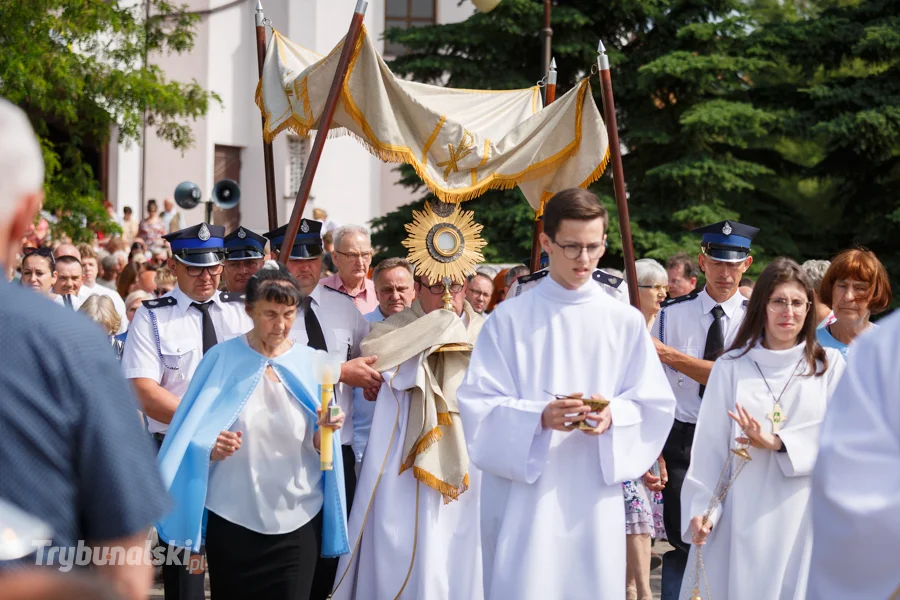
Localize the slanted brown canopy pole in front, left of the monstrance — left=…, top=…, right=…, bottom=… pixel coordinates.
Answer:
left=278, top=0, right=369, bottom=264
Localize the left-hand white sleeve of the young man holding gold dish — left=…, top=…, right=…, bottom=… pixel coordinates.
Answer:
left=456, top=318, right=552, bottom=484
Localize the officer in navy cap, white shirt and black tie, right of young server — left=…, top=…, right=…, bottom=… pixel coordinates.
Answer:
left=652, top=221, right=759, bottom=600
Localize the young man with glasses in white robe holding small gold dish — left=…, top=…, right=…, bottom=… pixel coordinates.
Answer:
left=457, top=189, right=675, bottom=600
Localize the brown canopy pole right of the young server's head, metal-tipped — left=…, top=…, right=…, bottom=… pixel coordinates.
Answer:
left=597, top=41, right=641, bottom=310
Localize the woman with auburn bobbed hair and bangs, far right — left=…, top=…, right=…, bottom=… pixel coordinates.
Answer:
left=816, top=248, right=891, bottom=358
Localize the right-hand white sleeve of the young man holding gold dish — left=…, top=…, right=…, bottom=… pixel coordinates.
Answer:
left=600, top=318, right=675, bottom=485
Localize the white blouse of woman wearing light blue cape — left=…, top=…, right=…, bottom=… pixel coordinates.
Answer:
left=206, top=375, right=323, bottom=534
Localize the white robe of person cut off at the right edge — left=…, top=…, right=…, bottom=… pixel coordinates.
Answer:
left=807, top=316, right=900, bottom=600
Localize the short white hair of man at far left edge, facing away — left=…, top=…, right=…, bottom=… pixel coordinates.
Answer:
left=0, top=98, right=44, bottom=219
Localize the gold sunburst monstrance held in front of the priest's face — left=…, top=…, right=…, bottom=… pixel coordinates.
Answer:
left=403, top=199, right=487, bottom=352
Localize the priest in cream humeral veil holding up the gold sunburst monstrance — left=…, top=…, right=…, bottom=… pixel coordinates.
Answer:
left=333, top=201, right=486, bottom=600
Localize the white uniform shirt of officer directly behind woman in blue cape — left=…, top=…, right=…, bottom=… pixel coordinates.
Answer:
left=291, top=285, right=369, bottom=446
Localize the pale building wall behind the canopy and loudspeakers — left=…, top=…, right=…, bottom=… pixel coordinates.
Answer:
left=109, top=0, right=473, bottom=233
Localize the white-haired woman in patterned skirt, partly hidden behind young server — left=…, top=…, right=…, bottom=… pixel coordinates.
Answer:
left=622, top=258, right=669, bottom=600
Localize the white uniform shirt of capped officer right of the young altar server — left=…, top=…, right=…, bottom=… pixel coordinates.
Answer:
left=652, top=288, right=747, bottom=423
